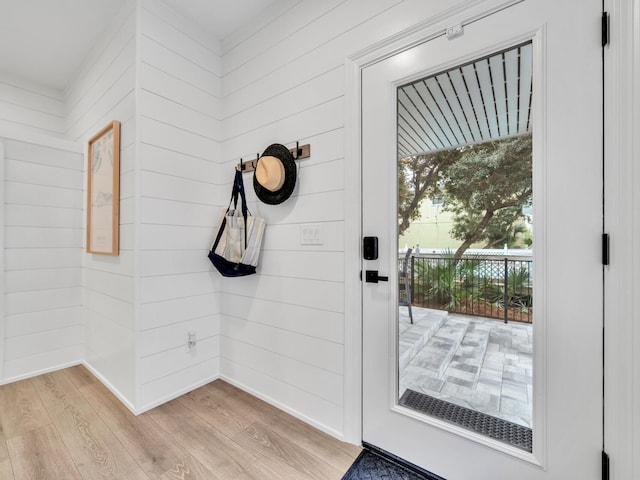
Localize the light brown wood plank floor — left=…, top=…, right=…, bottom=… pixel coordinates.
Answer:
left=0, top=366, right=360, bottom=480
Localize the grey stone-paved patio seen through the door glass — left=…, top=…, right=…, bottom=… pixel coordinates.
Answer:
left=398, top=306, right=533, bottom=428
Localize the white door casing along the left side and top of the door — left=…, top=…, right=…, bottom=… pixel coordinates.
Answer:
left=344, top=0, right=540, bottom=444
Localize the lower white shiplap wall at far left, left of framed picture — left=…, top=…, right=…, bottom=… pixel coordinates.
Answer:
left=1, top=135, right=84, bottom=381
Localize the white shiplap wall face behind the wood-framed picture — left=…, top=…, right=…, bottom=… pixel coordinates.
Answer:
left=65, top=0, right=137, bottom=408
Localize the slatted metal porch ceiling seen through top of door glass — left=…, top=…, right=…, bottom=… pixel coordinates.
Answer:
left=398, top=42, right=532, bottom=158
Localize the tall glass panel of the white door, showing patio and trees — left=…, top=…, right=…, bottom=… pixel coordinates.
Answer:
left=396, top=42, right=533, bottom=452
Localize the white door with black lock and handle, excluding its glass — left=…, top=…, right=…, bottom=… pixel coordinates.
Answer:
left=362, top=0, right=603, bottom=480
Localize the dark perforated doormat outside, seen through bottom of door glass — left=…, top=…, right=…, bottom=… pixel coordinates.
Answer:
left=399, top=389, right=533, bottom=452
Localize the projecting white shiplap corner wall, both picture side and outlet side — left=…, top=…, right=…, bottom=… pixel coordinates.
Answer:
left=58, top=0, right=220, bottom=411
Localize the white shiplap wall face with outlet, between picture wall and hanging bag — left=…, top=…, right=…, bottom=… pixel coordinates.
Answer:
left=136, top=1, right=221, bottom=410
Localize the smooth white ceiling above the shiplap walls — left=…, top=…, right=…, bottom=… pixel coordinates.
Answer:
left=0, top=0, right=276, bottom=90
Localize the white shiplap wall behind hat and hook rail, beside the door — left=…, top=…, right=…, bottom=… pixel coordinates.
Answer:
left=220, top=0, right=468, bottom=438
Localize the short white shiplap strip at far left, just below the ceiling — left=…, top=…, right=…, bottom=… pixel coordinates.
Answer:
left=0, top=73, right=64, bottom=138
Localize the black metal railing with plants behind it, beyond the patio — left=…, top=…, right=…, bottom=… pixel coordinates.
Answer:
left=399, top=253, right=533, bottom=323
